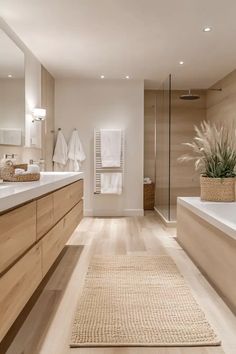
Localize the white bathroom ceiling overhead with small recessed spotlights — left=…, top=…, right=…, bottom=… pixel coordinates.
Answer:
left=0, top=0, right=236, bottom=88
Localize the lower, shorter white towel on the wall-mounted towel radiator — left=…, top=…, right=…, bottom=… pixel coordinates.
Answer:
left=101, top=172, right=122, bottom=194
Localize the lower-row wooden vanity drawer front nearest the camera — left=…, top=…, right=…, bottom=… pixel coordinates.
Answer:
left=0, top=243, right=42, bottom=341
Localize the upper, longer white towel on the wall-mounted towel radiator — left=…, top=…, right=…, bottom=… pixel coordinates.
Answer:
left=100, top=129, right=121, bottom=167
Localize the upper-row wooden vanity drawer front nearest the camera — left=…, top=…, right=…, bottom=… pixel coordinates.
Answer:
left=0, top=202, right=36, bottom=273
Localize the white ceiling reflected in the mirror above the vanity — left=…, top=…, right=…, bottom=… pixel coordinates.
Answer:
left=0, top=29, right=24, bottom=79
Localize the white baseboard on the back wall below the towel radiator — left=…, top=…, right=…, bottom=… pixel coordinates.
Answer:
left=84, top=209, right=144, bottom=217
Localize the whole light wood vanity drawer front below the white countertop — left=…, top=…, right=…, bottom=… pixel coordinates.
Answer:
left=0, top=180, right=83, bottom=341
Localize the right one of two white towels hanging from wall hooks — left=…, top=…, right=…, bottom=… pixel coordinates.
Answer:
left=68, top=129, right=86, bottom=172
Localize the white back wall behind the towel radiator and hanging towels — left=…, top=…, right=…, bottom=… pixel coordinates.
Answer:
left=55, top=79, right=144, bottom=216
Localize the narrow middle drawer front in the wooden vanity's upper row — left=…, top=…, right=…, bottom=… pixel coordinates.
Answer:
left=37, top=193, right=53, bottom=239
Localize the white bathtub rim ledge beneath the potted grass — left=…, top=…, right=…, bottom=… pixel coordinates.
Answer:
left=178, top=197, right=236, bottom=239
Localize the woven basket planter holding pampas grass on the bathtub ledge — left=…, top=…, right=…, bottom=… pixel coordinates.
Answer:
left=200, top=176, right=236, bottom=202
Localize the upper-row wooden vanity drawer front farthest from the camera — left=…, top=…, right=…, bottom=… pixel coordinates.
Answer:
left=53, top=180, right=83, bottom=223
